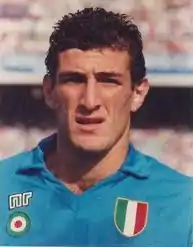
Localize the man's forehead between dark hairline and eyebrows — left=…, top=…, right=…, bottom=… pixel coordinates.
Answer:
left=58, top=49, right=130, bottom=73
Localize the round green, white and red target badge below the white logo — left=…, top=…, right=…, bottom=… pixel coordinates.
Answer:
left=7, top=212, right=31, bottom=237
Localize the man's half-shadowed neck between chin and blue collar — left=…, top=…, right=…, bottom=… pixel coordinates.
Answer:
left=47, top=130, right=129, bottom=193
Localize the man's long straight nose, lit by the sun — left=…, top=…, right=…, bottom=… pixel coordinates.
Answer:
left=81, top=79, right=100, bottom=111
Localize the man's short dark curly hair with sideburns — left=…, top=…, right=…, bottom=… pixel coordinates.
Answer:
left=45, top=8, right=146, bottom=84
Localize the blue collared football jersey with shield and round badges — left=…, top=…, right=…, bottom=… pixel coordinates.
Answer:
left=0, top=136, right=193, bottom=247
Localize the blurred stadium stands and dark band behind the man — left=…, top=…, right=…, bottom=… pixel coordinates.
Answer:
left=0, top=0, right=193, bottom=175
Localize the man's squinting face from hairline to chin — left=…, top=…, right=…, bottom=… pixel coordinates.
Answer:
left=44, top=49, right=149, bottom=152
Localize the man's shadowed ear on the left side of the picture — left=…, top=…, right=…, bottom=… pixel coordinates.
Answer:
left=43, top=75, right=55, bottom=109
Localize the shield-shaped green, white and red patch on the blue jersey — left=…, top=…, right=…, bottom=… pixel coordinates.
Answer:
left=114, top=198, right=148, bottom=237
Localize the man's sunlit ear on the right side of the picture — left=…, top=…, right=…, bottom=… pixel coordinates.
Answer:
left=131, top=78, right=150, bottom=112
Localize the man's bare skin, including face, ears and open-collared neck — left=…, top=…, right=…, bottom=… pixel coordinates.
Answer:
left=43, top=49, right=149, bottom=193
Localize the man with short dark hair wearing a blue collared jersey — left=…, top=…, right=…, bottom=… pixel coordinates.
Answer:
left=0, top=8, right=192, bottom=247
